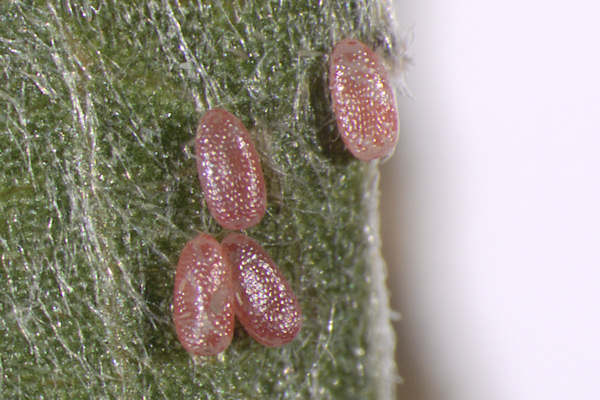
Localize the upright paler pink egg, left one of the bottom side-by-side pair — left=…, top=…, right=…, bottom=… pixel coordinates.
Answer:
left=173, top=233, right=234, bottom=356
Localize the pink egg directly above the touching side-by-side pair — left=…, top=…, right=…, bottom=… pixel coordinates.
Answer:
left=195, top=109, right=267, bottom=230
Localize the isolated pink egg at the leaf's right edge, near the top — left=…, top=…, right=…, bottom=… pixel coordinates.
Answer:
left=329, top=39, right=398, bottom=161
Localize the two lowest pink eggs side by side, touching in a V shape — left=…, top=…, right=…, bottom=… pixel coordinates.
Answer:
left=173, top=232, right=302, bottom=356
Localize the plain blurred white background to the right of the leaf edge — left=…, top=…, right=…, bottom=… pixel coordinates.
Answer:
left=381, top=0, right=600, bottom=400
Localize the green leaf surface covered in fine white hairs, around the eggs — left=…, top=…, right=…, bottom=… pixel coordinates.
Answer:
left=0, top=0, right=394, bottom=399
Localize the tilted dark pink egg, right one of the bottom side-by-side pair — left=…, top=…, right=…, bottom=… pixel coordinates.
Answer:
left=221, top=233, right=302, bottom=347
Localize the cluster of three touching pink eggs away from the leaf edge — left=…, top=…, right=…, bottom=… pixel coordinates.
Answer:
left=173, top=109, right=302, bottom=356
